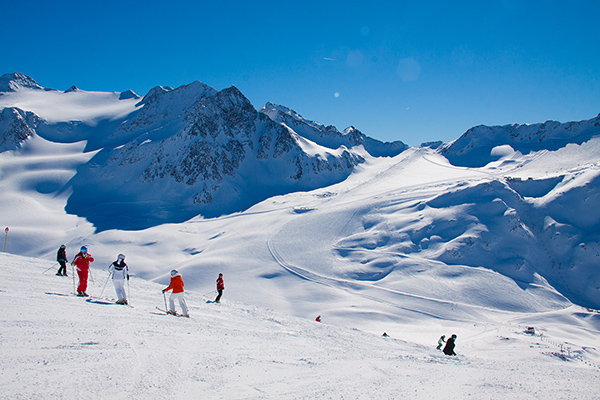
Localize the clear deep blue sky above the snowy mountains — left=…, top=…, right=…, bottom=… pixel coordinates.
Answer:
left=0, top=0, right=600, bottom=145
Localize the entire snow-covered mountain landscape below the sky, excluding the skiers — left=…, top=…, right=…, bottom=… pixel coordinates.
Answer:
left=0, top=74, right=600, bottom=399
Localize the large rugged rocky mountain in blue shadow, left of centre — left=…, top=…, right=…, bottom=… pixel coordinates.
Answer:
left=66, top=82, right=364, bottom=229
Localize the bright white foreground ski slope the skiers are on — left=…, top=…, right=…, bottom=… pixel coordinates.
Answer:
left=0, top=254, right=600, bottom=399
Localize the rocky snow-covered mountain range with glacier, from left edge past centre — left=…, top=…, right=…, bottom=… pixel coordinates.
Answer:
left=0, top=73, right=398, bottom=230
